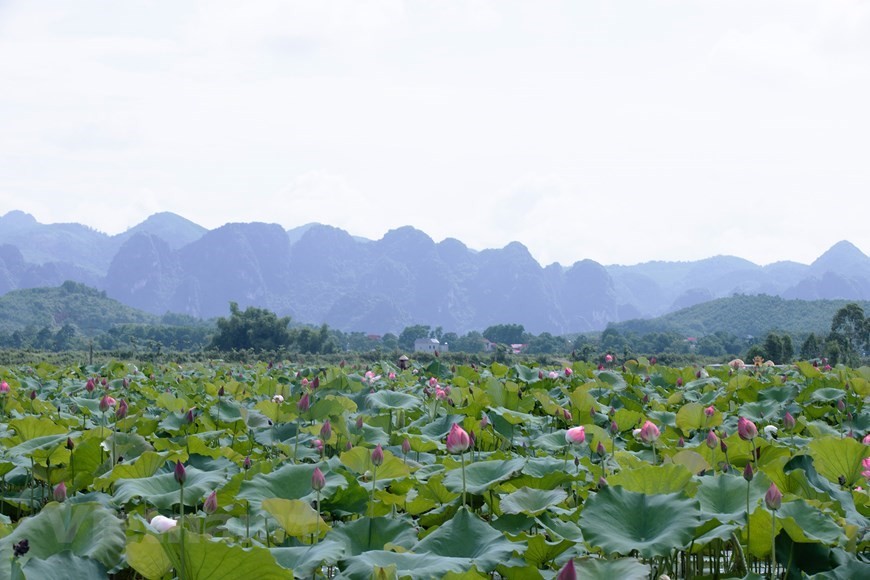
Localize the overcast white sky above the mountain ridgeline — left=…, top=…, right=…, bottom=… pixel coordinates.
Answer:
left=0, top=0, right=870, bottom=265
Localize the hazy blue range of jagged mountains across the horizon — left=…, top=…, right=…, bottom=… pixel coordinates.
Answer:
left=0, top=211, right=870, bottom=334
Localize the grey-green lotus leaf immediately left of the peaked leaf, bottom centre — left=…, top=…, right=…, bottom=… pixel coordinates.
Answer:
left=325, top=517, right=417, bottom=556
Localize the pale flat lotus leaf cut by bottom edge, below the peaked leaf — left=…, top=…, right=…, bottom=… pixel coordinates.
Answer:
left=339, top=550, right=471, bottom=580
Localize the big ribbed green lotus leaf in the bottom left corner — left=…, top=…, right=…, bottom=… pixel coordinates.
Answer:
left=0, top=502, right=125, bottom=569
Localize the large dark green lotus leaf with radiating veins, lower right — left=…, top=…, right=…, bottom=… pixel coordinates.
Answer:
left=579, top=487, right=701, bottom=558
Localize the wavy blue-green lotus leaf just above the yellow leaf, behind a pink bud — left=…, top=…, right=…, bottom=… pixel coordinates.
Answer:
left=240, top=463, right=347, bottom=510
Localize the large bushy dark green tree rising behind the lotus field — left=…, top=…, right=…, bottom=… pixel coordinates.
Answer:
left=211, top=302, right=292, bottom=350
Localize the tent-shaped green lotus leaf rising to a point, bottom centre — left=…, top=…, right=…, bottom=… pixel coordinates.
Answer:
left=413, top=509, right=521, bottom=572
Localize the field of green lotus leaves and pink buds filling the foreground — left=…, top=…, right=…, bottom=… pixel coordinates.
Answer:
left=0, top=358, right=870, bottom=580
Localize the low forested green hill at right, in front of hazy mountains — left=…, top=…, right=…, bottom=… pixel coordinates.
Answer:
left=610, top=295, right=870, bottom=337
